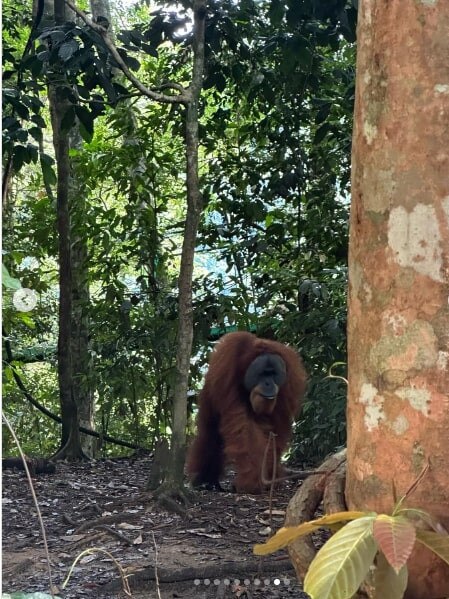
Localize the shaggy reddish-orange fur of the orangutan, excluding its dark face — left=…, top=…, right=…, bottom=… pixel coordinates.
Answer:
left=187, top=332, right=306, bottom=493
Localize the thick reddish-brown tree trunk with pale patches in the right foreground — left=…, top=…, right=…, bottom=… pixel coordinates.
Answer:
left=346, top=0, right=449, bottom=599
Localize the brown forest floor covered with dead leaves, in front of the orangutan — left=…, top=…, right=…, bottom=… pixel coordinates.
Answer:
left=2, top=457, right=307, bottom=599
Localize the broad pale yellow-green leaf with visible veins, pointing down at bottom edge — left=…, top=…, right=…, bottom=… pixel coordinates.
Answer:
left=304, top=516, right=377, bottom=599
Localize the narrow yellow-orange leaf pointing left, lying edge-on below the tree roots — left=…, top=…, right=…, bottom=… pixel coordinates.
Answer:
left=253, top=511, right=366, bottom=555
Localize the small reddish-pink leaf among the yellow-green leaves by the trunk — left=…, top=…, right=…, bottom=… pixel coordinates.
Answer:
left=373, top=514, right=416, bottom=573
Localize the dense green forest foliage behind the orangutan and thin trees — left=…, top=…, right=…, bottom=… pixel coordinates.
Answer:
left=3, top=0, right=356, bottom=461
